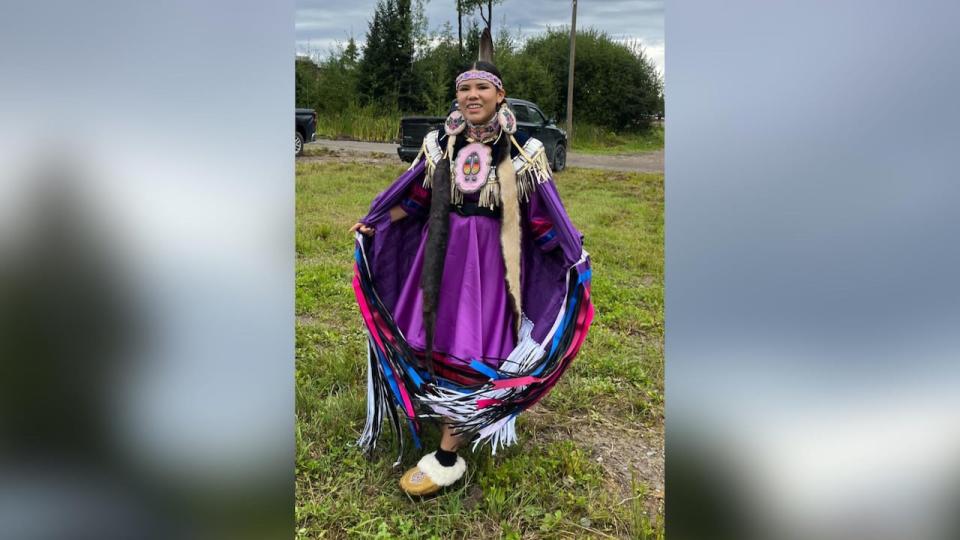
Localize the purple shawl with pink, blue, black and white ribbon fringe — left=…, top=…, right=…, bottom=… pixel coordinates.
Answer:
left=353, top=132, right=593, bottom=463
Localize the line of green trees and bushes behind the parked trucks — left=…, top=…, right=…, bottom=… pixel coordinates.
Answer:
left=304, top=10, right=663, bottom=131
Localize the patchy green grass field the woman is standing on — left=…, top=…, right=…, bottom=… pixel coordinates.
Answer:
left=296, top=158, right=663, bottom=539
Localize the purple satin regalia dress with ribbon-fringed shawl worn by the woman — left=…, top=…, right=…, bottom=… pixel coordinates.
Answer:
left=353, top=127, right=593, bottom=460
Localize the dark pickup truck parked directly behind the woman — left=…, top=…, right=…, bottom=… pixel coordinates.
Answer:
left=397, top=97, right=568, bottom=172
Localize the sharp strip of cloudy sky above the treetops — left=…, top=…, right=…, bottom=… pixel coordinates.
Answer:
left=296, top=0, right=664, bottom=73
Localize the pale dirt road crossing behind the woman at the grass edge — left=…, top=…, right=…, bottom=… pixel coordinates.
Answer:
left=301, top=139, right=663, bottom=173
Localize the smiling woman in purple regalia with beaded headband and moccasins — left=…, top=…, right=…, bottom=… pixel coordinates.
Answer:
left=351, top=61, right=593, bottom=495
